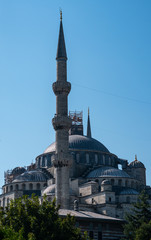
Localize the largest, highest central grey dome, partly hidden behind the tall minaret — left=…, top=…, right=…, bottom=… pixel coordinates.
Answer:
left=44, top=135, right=109, bottom=153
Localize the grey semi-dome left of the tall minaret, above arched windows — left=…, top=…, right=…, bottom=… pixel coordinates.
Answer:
left=13, top=170, right=47, bottom=182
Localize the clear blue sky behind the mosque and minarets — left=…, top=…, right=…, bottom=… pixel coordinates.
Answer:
left=0, top=0, right=151, bottom=186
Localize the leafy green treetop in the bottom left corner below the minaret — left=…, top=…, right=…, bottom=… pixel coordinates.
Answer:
left=0, top=196, right=87, bottom=240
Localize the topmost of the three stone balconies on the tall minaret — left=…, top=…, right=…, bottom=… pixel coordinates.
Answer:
left=52, top=81, right=71, bottom=95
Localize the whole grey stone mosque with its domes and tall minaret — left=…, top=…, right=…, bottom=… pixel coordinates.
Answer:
left=0, top=16, right=151, bottom=239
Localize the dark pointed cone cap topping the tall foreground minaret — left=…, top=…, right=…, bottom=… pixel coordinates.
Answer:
left=56, top=10, right=67, bottom=60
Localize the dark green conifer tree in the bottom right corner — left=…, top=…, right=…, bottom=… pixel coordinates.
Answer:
left=124, top=191, right=151, bottom=240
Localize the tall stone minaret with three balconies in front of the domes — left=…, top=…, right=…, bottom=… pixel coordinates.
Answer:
left=52, top=11, right=72, bottom=209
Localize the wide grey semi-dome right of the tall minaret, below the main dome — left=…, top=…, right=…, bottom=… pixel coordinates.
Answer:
left=86, top=167, right=130, bottom=178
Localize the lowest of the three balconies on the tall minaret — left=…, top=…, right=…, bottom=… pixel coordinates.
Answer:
left=51, top=152, right=73, bottom=167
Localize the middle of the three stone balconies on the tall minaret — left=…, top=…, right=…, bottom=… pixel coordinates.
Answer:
left=52, top=115, right=72, bottom=130
